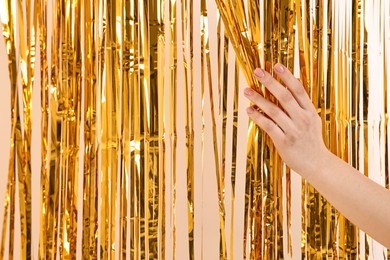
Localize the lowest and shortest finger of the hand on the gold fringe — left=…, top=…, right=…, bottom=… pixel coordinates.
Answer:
left=246, top=107, right=285, bottom=142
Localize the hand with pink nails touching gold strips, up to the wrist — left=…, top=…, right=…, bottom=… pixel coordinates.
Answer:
left=244, top=64, right=330, bottom=177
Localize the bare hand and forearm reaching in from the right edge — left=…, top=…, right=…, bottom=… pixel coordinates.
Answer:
left=244, top=64, right=390, bottom=248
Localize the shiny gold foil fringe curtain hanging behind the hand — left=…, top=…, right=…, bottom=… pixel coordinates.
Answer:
left=0, top=0, right=390, bottom=259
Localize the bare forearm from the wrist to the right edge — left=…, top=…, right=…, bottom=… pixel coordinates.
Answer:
left=301, top=152, right=390, bottom=248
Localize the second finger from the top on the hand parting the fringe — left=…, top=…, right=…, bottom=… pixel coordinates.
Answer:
left=255, top=68, right=302, bottom=117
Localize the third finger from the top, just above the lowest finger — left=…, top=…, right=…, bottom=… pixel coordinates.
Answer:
left=244, top=88, right=294, bottom=132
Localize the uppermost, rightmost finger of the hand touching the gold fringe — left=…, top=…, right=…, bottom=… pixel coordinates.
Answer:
left=274, top=63, right=315, bottom=111
